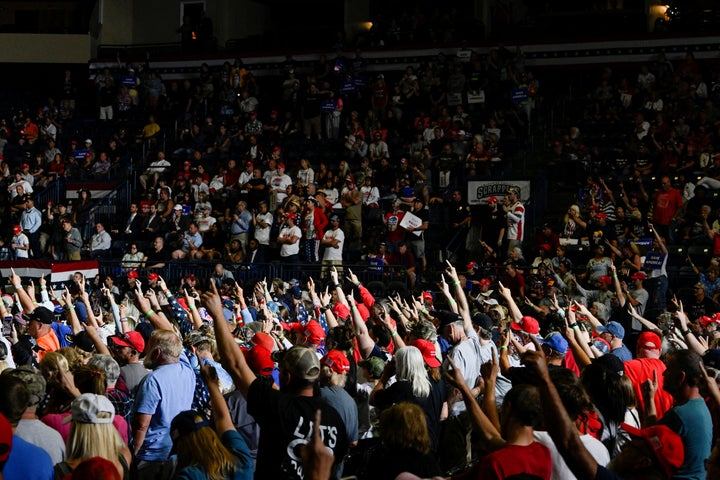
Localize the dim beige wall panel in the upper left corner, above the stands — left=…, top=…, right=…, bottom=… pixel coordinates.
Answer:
left=0, top=33, right=91, bottom=64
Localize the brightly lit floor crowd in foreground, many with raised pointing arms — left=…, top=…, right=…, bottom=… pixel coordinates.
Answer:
left=0, top=249, right=720, bottom=479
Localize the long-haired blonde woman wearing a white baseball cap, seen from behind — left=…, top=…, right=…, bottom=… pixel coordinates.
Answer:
left=55, top=393, right=132, bottom=479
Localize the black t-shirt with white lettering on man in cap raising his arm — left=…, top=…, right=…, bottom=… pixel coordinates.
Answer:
left=247, top=380, right=348, bottom=480
